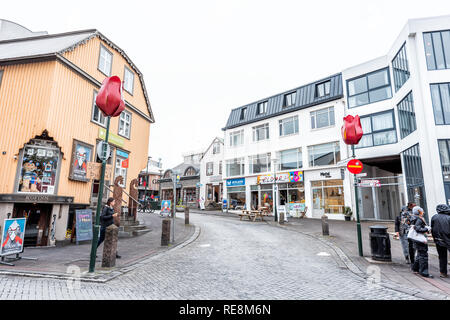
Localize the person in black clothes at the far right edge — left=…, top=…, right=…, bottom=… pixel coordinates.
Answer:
left=431, top=204, right=450, bottom=278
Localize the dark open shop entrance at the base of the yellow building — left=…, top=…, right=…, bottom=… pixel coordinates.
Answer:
left=13, top=203, right=53, bottom=247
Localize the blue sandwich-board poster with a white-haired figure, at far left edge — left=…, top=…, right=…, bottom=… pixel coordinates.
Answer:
left=0, top=218, right=27, bottom=256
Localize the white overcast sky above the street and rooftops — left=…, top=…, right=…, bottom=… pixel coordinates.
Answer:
left=0, top=0, right=450, bottom=168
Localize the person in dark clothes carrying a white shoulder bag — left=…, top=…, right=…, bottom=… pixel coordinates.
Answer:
left=408, top=206, right=433, bottom=278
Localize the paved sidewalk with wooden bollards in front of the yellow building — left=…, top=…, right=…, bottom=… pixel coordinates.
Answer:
left=0, top=211, right=196, bottom=282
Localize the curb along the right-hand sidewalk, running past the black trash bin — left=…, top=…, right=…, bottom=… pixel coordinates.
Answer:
left=266, top=221, right=450, bottom=300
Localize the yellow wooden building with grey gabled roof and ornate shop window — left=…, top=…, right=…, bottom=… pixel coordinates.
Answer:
left=0, top=20, right=154, bottom=246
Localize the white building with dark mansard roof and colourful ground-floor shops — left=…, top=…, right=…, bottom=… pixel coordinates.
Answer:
left=223, top=74, right=351, bottom=219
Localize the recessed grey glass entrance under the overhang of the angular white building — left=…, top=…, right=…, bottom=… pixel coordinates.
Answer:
left=358, top=175, right=406, bottom=220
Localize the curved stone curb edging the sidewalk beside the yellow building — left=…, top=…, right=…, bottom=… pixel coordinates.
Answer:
left=0, top=225, right=201, bottom=283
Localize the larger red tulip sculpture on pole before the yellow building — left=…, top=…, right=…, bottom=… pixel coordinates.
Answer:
left=95, top=76, right=125, bottom=117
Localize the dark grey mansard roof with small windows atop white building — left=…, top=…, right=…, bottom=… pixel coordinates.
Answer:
left=222, top=73, right=344, bottom=131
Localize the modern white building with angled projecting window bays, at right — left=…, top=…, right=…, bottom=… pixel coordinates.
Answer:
left=342, top=16, right=450, bottom=220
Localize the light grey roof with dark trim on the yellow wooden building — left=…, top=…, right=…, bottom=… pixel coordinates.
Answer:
left=0, top=29, right=155, bottom=122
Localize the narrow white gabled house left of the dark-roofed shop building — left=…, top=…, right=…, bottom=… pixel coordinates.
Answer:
left=200, top=137, right=224, bottom=206
